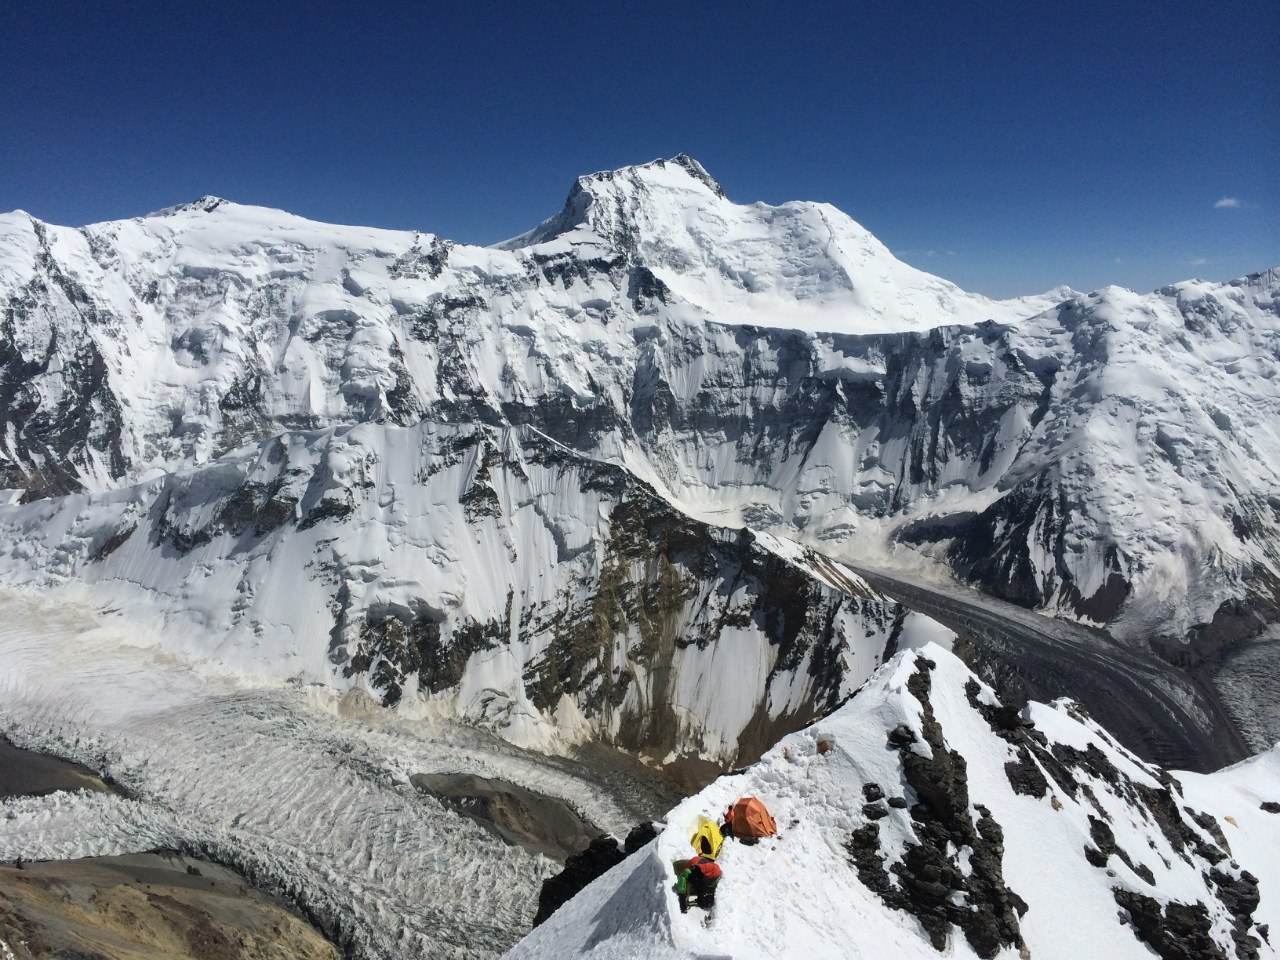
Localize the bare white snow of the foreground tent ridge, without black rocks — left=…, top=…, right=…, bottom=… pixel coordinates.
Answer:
left=507, top=644, right=1280, bottom=960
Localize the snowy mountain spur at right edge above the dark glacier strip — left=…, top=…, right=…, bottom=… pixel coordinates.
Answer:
left=948, top=271, right=1280, bottom=650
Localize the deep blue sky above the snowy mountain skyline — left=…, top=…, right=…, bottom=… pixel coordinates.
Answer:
left=0, top=0, right=1280, bottom=296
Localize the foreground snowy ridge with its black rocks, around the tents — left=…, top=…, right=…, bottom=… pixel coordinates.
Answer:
left=508, top=645, right=1280, bottom=960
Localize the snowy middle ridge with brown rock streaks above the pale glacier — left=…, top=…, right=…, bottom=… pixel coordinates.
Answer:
left=0, top=421, right=916, bottom=776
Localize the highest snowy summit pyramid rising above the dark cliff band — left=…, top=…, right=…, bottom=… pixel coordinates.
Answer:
left=499, top=155, right=1071, bottom=333
